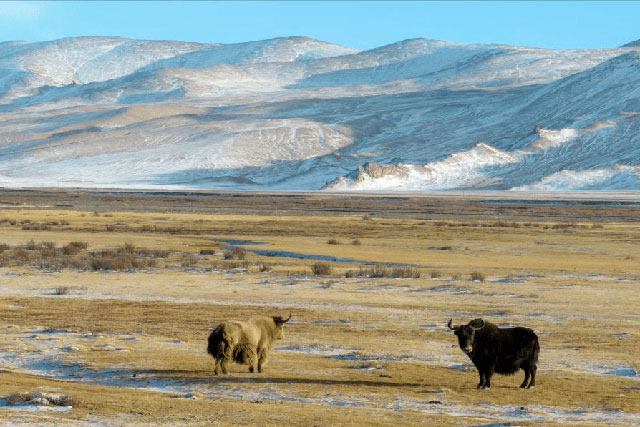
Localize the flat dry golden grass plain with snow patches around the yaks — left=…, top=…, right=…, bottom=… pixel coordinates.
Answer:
left=0, top=191, right=640, bottom=426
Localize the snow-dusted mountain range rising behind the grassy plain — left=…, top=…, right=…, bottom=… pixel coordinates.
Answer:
left=0, top=37, right=640, bottom=191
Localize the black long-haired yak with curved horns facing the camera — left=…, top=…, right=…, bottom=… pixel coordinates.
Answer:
left=447, top=319, right=540, bottom=389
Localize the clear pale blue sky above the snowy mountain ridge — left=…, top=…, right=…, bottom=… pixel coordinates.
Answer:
left=0, top=1, right=640, bottom=49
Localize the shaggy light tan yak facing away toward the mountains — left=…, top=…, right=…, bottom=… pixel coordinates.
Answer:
left=207, top=314, right=291, bottom=375
